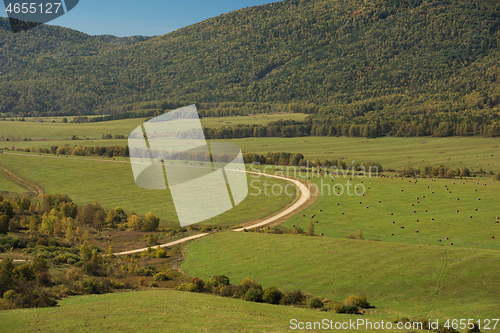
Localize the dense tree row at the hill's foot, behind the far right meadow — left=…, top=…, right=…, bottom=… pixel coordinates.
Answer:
left=203, top=113, right=500, bottom=139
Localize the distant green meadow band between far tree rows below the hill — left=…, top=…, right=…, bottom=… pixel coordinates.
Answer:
left=0, top=113, right=500, bottom=172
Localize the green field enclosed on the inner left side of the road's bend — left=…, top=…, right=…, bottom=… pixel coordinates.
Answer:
left=0, top=154, right=294, bottom=226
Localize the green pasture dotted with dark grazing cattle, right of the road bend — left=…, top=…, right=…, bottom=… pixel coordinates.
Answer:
left=276, top=172, right=500, bottom=250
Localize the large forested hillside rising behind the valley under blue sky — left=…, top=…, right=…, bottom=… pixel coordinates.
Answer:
left=0, top=0, right=500, bottom=135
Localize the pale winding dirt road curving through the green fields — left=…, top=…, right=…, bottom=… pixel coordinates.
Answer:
left=114, top=171, right=311, bottom=255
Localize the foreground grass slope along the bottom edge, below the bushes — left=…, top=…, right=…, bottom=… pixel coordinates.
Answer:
left=0, top=290, right=402, bottom=333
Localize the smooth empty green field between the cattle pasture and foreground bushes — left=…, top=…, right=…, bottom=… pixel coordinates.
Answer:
left=182, top=232, right=500, bottom=322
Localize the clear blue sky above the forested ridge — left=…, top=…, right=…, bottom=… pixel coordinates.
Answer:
left=0, top=0, right=277, bottom=37
